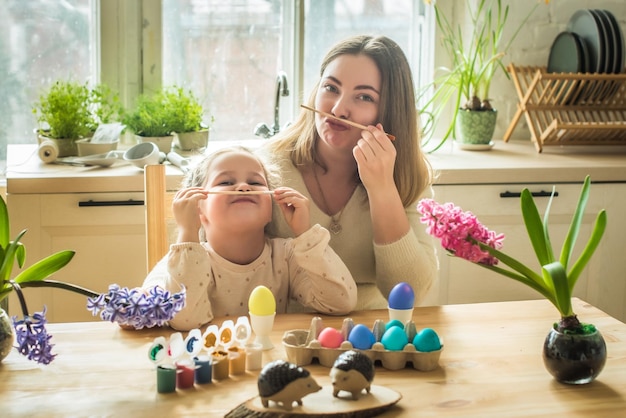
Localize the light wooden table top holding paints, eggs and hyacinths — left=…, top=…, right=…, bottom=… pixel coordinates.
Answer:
left=0, top=300, right=626, bottom=418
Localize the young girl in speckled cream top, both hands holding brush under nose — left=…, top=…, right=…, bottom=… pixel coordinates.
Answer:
left=144, top=147, right=357, bottom=330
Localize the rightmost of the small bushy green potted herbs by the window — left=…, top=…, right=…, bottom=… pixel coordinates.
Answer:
left=165, top=86, right=209, bottom=150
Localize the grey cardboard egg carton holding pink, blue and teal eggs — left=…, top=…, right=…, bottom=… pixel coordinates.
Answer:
left=282, top=319, right=443, bottom=372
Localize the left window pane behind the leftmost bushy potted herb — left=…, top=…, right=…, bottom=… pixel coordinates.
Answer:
left=0, top=0, right=98, bottom=172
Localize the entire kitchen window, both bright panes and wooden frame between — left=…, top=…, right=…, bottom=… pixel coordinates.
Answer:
left=0, top=0, right=432, bottom=172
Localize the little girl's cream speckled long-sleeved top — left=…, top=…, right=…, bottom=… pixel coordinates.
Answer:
left=143, top=225, right=357, bottom=330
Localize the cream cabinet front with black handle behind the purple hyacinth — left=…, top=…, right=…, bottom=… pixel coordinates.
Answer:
left=7, top=192, right=146, bottom=322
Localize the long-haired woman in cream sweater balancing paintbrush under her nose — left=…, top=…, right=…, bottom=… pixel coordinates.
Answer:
left=260, top=36, right=438, bottom=309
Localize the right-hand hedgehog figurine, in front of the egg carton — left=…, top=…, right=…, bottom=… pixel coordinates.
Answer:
left=330, top=350, right=376, bottom=400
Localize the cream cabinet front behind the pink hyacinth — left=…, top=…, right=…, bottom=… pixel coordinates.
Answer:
left=428, top=183, right=626, bottom=320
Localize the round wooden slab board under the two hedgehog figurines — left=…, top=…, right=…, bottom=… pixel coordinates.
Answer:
left=225, top=383, right=402, bottom=418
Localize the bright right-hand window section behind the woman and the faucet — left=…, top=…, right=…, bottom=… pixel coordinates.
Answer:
left=161, top=0, right=432, bottom=140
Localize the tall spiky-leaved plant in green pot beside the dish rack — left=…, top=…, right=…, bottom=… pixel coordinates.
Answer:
left=418, top=0, right=537, bottom=152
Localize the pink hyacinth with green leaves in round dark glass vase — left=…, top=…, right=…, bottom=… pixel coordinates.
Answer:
left=418, top=176, right=607, bottom=384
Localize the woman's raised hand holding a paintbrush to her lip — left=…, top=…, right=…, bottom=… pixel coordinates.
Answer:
left=352, top=123, right=396, bottom=194
